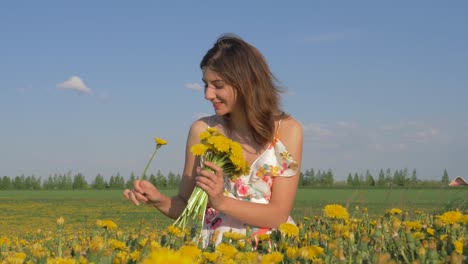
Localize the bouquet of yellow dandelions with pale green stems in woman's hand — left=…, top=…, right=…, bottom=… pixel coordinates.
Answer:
left=174, top=127, right=250, bottom=233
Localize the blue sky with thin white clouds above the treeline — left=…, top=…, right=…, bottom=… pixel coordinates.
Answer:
left=0, top=1, right=468, bottom=182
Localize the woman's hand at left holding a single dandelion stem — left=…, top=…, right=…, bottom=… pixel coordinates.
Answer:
left=123, top=180, right=163, bottom=205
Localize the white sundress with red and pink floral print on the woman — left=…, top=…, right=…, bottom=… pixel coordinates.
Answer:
left=201, top=120, right=298, bottom=246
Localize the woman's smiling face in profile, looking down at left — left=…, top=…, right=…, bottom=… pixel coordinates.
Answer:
left=203, top=68, right=236, bottom=116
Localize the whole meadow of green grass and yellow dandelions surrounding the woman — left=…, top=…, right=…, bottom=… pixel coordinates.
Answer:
left=0, top=188, right=468, bottom=264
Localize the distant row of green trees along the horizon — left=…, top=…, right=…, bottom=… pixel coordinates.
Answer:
left=0, top=169, right=449, bottom=190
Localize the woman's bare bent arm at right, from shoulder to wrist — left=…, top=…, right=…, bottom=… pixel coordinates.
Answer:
left=200, top=117, right=303, bottom=228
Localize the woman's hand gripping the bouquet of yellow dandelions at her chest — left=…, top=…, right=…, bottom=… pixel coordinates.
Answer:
left=195, top=161, right=226, bottom=210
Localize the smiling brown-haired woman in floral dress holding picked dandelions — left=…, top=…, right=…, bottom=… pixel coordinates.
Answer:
left=124, top=35, right=302, bottom=244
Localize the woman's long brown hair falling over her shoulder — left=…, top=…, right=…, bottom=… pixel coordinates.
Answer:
left=200, top=34, right=287, bottom=146
